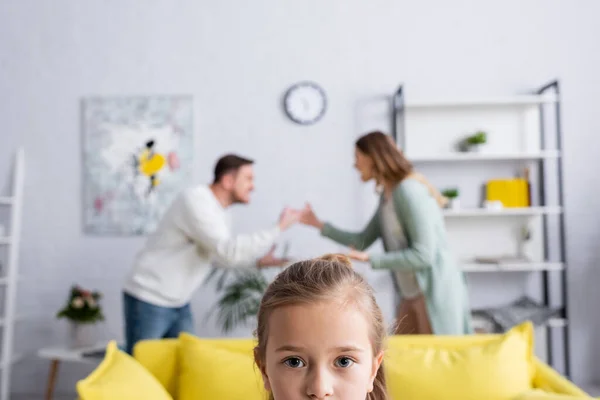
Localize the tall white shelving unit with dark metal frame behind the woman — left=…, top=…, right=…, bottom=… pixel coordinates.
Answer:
left=392, top=81, right=570, bottom=377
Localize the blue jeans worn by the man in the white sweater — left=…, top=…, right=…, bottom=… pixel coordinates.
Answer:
left=123, top=293, right=194, bottom=354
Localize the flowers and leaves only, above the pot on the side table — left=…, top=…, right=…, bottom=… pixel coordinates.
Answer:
left=56, top=286, right=104, bottom=324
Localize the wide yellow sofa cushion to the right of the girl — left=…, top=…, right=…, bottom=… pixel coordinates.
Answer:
left=384, top=323, right=534, bottom=400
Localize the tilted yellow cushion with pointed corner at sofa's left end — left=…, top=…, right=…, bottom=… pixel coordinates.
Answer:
left=77, top=341, right=173, bottom=400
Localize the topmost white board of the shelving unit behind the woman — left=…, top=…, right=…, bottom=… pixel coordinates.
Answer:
left=404, top=95, right=558, bottom=109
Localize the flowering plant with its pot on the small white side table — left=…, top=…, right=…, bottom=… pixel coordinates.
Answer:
left=56, top=285, right=104, bottom=348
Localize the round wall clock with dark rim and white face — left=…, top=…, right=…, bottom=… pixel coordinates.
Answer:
left=284, top=82, right=327, bottom=125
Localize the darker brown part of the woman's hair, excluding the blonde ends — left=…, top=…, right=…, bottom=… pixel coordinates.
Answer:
left=356, top=131, right=413, bottom=184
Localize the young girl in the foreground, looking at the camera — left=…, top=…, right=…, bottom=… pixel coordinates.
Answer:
left=254, top=255, right=388, bottom=400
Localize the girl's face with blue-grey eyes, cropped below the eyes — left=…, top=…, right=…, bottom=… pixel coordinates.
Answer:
left=261, top=302, right=383, bottom=400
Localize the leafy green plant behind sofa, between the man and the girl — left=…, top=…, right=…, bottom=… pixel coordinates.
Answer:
left=205, top=268, right=269, bottom=333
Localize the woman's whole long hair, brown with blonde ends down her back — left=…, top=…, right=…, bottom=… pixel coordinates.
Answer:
left=355, top=131, right=448, bottom=208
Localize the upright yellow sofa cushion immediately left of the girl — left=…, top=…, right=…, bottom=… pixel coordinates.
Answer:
left=178, top=333, right=267, bottom=400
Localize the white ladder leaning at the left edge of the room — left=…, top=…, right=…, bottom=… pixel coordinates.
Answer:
left=0, top=148, right=25, bottom=400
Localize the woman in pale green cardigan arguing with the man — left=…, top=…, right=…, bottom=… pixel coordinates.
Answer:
left=301, top=132, right=473, bottom=335
